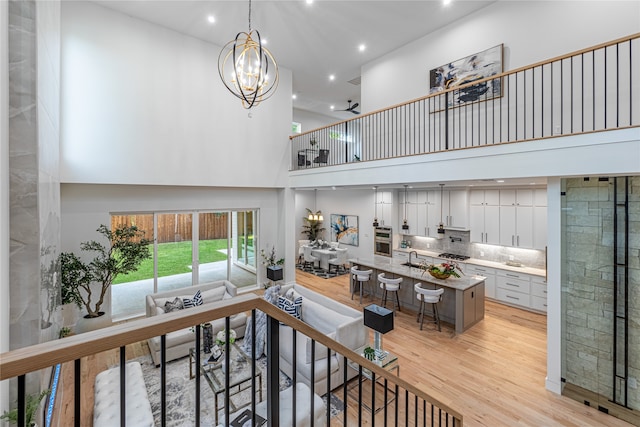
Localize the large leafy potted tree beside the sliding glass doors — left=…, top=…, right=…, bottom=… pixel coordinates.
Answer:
left=60, top=225, right=151, bottom=332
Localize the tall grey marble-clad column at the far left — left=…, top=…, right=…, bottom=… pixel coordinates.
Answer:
left=8, top=0, right=60, bottom=349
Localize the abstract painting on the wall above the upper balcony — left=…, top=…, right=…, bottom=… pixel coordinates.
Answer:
left=429, top=44, right=503, bottom=108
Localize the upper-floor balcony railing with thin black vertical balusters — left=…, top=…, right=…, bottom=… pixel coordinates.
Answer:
left=289, top=33, right=640, bottom=171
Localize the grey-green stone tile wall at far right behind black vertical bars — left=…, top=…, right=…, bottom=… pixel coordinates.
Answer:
left=562, top=176, right=640, bottom=409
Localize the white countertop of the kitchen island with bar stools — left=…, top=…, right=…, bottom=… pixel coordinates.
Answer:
left=349, top=255, right=485, bottom=291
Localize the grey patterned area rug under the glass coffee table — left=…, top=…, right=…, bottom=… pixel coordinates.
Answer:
left=136, top=350, right=344, bottom=427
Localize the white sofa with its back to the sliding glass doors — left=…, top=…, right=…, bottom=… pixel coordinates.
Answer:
left=146, top=280, right=247, bottom=366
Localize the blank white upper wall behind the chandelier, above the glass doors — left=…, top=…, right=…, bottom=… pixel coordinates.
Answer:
left=61, top=2, right=292, bottom=187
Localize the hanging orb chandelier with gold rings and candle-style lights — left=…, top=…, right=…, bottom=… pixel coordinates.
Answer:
left=218, top=0, right=278, bottom=109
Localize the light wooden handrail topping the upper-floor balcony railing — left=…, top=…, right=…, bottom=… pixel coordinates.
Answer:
left=289, top=33, right=640, bottom=141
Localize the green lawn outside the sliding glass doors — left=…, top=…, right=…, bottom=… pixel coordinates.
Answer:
left=113, top=239, right=227, bottom=284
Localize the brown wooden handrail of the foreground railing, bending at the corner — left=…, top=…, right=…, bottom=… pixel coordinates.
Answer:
left=0, top=293, right=463, bottom=426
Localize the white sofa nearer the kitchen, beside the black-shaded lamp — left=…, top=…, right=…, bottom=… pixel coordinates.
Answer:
left=280, top=284, right=367, bottom=396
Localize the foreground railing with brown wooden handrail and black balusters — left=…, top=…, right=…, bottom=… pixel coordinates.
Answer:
left=0, top=294, right=463, bottom=426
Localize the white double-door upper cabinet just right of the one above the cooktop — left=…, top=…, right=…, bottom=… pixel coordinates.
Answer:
left=469, top=190, right=500, bottom=245
